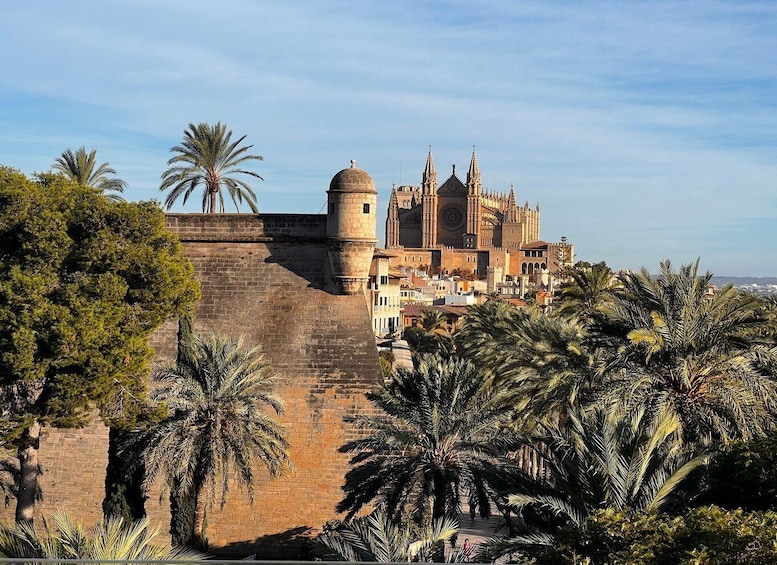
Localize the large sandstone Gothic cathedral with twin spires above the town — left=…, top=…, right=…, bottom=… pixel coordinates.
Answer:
left=386, top=150, right=572, bottom=278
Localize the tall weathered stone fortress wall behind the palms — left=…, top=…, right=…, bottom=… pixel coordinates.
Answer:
left=0, top=214, right=381, bottom=557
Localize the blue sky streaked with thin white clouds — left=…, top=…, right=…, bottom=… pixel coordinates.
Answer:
left=0, top=0, right=777, bottom=276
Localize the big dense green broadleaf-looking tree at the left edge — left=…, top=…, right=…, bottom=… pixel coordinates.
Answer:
left=0, top=168, right=199, bottom=520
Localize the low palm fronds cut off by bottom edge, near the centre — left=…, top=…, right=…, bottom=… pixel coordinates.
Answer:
left=313, top=510, right=463, bottom=563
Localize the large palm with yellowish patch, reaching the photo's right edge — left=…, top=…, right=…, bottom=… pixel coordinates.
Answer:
left=606, top=261, right=777, bottom=443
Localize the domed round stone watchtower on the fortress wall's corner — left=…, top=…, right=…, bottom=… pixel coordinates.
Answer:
left=326, top=161, right=378, bottom=294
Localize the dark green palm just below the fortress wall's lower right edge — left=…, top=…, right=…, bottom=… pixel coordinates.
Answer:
left=337, top=355, right=513, bottom=526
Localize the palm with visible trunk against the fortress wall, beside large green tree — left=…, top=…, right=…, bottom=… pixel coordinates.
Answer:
left=144, top=334, right=290, bottom=540
